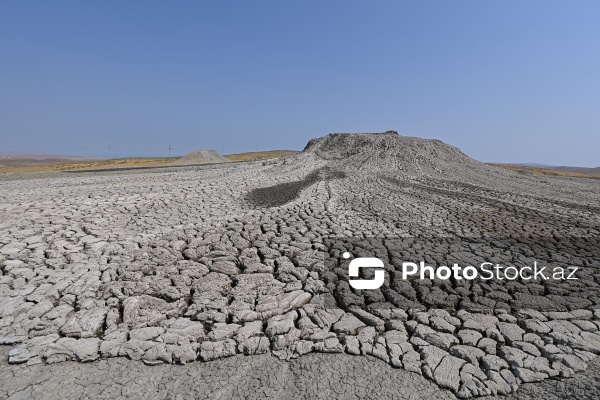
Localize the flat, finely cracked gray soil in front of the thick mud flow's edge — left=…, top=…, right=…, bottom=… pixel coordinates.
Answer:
left=0, top=346, right=454, bottom=400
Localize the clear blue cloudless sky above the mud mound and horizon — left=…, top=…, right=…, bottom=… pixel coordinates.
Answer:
left=0, top=0, right=600, bottom=166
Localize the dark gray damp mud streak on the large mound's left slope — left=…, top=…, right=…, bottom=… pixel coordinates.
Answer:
left=248, top=168, right=346, bottom=207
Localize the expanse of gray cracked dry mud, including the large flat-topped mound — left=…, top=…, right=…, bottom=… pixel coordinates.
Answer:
left=0, top=132, right=600, bottom=399
